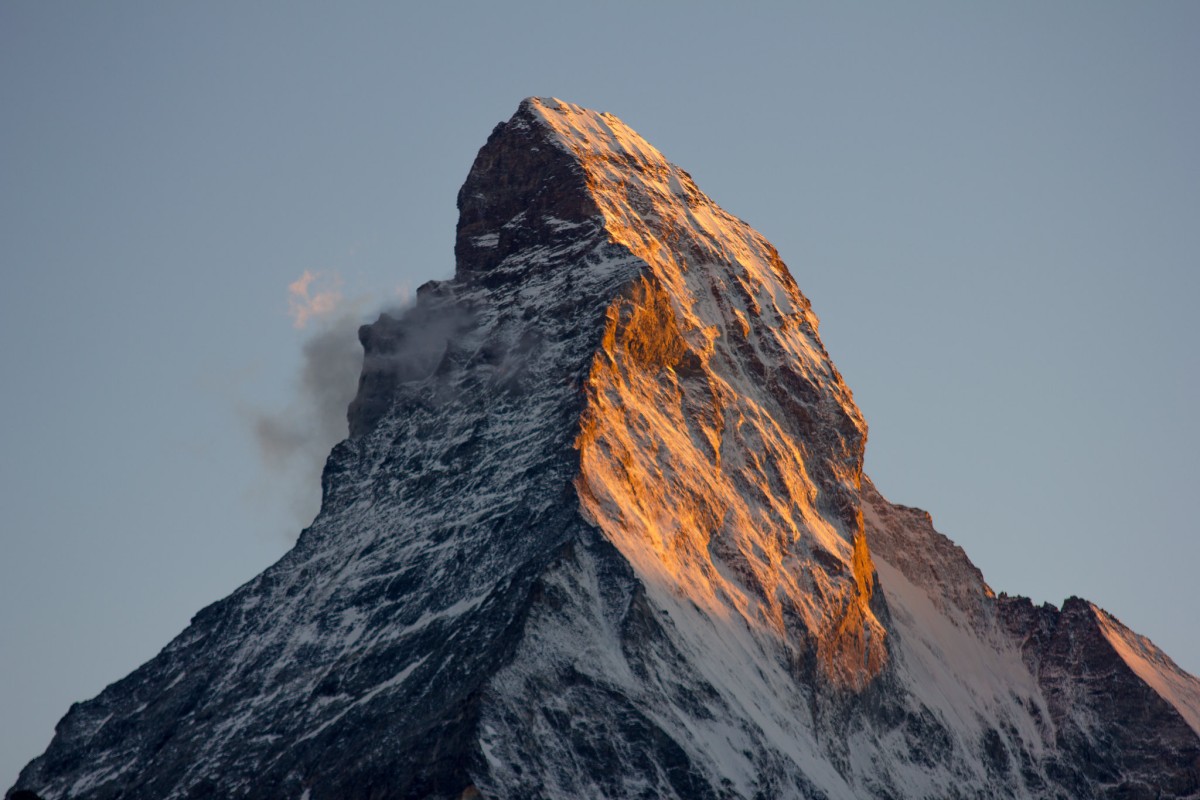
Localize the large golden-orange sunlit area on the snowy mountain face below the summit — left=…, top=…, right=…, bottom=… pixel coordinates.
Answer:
left=534, top=101, right=887, bottom=690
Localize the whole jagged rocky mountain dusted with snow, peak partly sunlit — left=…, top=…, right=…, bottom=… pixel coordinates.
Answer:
left=7, top=98, right=1200, bottom=800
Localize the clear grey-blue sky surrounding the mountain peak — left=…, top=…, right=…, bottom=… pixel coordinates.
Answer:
left=0, top=0, right=1200, bottom=788
